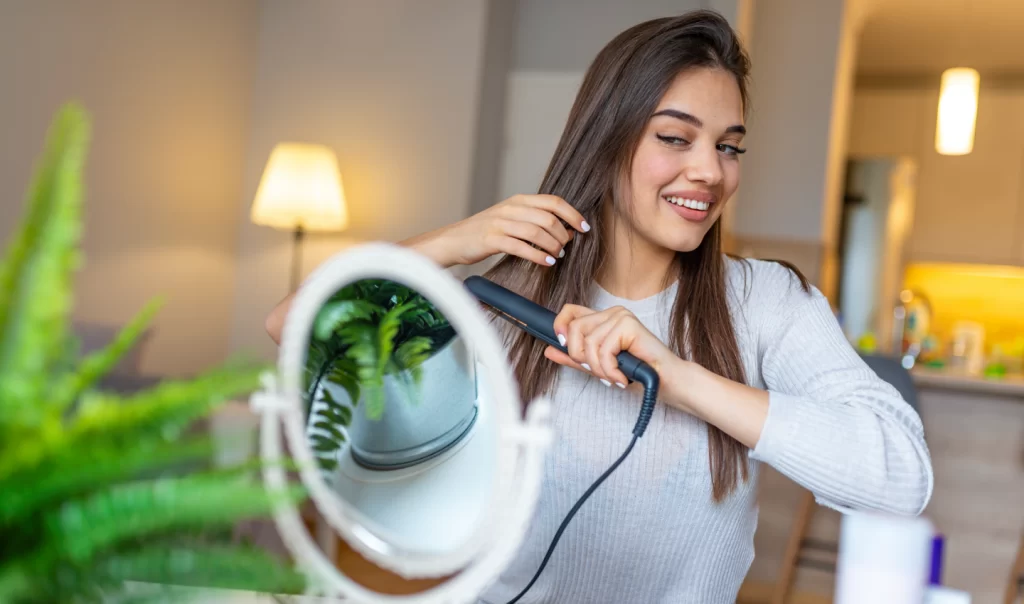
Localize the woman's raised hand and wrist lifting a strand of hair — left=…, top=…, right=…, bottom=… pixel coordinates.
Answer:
left=404, top=195, right=590, bottom=267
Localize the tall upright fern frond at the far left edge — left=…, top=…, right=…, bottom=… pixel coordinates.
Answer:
left=0, top=104, right=89, bottom=434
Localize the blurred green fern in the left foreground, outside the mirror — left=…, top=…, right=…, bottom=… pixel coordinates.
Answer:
left=0, top=104, right=305, bottom=604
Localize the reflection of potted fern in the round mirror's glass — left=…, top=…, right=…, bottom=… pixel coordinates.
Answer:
left=304, top=278, right=497, bottom=581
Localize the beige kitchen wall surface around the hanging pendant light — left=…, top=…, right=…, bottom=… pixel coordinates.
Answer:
left=850, top=83, right=1024, bottom=266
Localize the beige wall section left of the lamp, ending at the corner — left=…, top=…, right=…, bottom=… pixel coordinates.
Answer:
left=0, top=0, right=257, bottom=375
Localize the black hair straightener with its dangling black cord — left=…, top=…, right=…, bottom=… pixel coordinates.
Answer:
left=463, top=276, right=658, bottom=604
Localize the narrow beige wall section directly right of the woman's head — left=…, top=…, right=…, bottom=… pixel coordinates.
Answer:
left=731, top=0, right=865, bottom=293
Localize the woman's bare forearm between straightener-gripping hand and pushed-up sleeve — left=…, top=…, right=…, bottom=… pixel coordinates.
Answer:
left=660, top=357, right=768, bottom=448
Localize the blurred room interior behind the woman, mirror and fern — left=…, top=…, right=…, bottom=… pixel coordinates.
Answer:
left=0, top=0, right=1024, bottom=604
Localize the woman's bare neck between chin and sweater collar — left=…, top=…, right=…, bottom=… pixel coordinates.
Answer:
left=597, top=212, right=676, bottom=300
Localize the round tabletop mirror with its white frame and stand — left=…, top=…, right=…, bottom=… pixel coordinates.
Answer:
left=254, top=244, right=550, bottom=602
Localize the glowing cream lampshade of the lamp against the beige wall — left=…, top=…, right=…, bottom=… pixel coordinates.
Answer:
left=250, top=142, right=348, bottom=230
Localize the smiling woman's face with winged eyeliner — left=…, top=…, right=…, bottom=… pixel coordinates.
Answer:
left=627, top=69, right=745, bottom=252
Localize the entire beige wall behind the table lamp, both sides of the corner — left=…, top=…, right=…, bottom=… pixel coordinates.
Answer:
left=0, top=0, right=493, bottom=375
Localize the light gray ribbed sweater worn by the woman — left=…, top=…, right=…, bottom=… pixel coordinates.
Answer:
left=480, top=260, right=932, bottom=604
